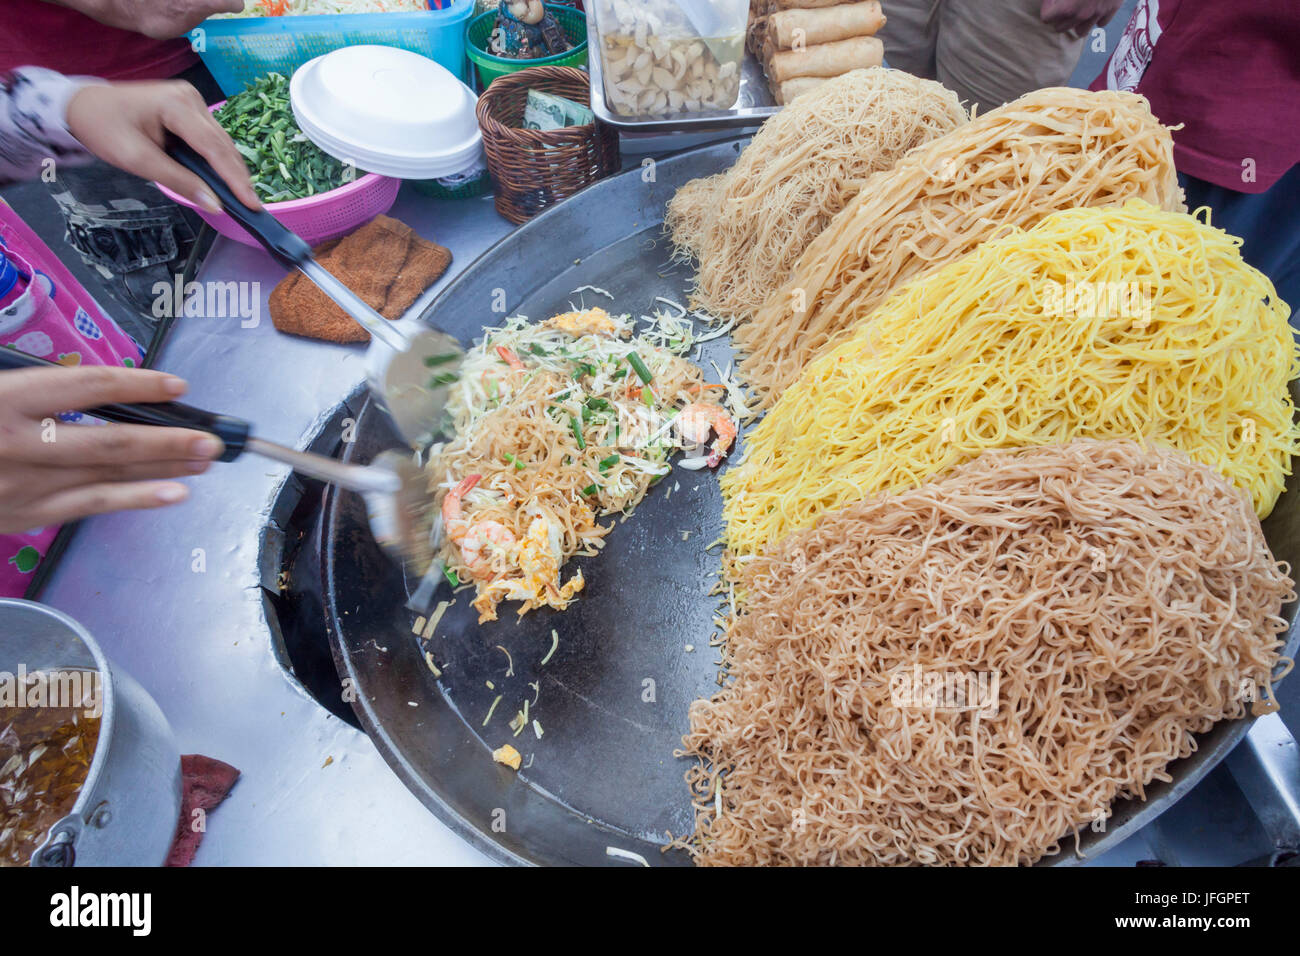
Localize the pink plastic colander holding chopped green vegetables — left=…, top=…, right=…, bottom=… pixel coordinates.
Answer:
left=159, top=100, right=402, bottom=248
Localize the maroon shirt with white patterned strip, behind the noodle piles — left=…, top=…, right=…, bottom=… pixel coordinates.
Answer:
left=1092, top=0, right=1300, bottom=193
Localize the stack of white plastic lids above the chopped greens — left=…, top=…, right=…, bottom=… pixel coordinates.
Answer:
left=289, top=46, right=482, bottom=179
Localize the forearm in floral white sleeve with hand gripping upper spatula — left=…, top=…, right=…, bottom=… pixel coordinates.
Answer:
left=0, top=66, right=261, bottom=212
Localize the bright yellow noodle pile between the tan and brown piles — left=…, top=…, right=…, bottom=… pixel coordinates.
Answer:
left=722, top=200, right=1300, bottom=554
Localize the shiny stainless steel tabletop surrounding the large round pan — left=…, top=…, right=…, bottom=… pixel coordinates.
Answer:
left=35, top=179, right=1284, bottom=866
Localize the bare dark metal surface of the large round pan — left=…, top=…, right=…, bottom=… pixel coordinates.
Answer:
left=326, top=217, right=729, bottom=862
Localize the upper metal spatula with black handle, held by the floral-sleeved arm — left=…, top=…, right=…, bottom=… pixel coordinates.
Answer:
left=166, top=137, right=464, bottom=447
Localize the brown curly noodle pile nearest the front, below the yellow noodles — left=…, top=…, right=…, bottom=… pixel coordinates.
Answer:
left=685, top=441, right=1294, bottom=865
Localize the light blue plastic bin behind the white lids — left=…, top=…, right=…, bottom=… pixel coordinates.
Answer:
left=190, top=0, right=475, bottom=96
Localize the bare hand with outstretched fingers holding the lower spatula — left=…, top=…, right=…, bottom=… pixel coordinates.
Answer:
left=0, top=365, right=222, bottom=535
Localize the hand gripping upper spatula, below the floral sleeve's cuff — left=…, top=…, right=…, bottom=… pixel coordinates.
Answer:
left=68, top=79, right=261, bottom=212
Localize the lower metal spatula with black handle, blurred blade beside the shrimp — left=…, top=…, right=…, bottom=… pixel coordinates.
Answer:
left=0, top=349, right=442, bottom=580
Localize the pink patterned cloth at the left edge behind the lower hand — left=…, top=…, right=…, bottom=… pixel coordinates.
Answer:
left=0, top=202, right=143, bottom=597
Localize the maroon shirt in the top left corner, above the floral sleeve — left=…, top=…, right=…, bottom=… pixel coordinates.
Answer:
left=0, top=0, right=198, bottom=79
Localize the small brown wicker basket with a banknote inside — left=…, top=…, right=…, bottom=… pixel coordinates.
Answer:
left=478, top=66, right=619, bottom=224
